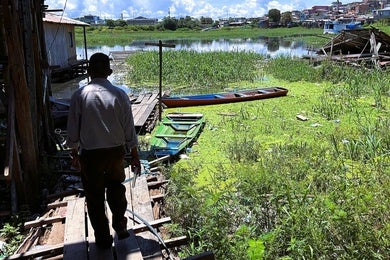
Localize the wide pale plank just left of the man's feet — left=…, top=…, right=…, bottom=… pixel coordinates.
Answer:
left=64, top=198, right=88, bottom=260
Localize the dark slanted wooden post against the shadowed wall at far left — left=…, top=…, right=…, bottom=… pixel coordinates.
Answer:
left=1, top=0, right=40, bottom=210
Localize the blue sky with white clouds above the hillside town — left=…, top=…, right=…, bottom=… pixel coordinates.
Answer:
left=45, top=0, right=356, bottom=20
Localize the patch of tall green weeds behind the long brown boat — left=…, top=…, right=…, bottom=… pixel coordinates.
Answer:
left=127, top=50, right=263, bottom=94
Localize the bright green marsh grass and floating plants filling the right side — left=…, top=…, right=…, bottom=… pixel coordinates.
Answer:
left=133, top=53, right=390, bottom=259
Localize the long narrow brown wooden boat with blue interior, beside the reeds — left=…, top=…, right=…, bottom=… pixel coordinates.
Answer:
left=161, top=87, right=288, bottom=108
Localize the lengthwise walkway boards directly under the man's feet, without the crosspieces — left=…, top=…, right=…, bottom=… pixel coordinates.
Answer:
left=63, top=168, right=164, bottom=260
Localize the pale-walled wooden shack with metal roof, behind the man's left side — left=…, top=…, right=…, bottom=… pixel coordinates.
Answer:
left=43, top=13, right=89, bottom=81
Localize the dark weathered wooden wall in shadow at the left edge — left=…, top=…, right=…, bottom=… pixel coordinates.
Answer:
left=0, top=0, right=53, bottom=211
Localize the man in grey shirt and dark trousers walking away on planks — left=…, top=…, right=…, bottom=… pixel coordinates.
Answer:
left=67, top=53, right=140, bottom=248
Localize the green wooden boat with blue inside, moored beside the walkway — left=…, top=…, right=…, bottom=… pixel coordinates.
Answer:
left=150, top=113, right=205, bottom=157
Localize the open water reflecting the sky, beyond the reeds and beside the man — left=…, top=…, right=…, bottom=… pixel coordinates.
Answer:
left=52, top=37, right=314, bottom=98
